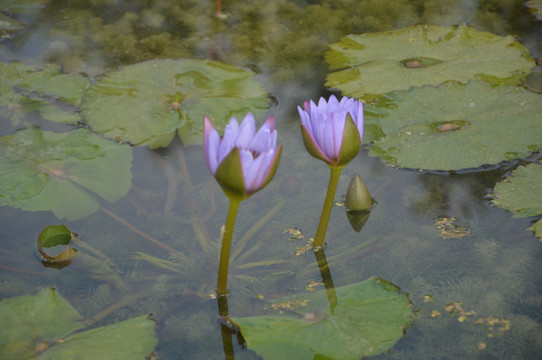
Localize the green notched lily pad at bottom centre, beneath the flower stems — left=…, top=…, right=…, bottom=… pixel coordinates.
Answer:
left=235, top=278, right=413, bottom=360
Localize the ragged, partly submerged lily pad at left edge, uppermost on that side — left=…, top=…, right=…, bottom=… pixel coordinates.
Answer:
left=0, top=63, right=89, bottom=126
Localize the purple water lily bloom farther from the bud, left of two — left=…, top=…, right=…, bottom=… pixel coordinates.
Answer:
left=203, top=113, right=282, bottom=200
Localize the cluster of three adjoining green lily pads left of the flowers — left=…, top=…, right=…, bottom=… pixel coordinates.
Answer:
left=0, top=59, right=269, bottom=220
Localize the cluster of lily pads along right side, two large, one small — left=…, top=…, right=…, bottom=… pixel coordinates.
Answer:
left=326, top=23, right=542, bottom=237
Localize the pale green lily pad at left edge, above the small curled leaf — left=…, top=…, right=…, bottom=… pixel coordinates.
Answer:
left=0, top=128, right=132, bottom=220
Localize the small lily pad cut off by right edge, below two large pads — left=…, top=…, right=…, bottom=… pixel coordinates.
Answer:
left=493, top=164, right=542, bottom=239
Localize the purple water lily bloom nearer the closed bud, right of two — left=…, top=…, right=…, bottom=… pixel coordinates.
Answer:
left=297, top=95, right=363, bottom=167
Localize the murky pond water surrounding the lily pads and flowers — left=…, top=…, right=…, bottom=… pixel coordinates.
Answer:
left=0, top=0, right=542, bottom=359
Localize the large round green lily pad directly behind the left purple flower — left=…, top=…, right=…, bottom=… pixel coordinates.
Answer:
left=81, top=59, right=269, bottom=148
